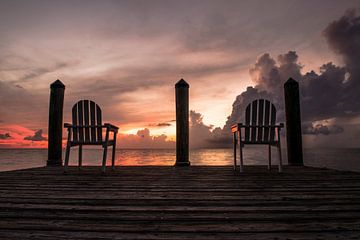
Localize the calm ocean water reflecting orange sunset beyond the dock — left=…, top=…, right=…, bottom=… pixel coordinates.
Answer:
left=0, top=146, right=360, bottom=171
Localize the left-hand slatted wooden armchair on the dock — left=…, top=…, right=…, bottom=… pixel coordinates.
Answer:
left=64, top=100, right=119, bottom=173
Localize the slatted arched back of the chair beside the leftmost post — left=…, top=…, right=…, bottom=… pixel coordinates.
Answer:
left=72, top=100, right=102, bottom=143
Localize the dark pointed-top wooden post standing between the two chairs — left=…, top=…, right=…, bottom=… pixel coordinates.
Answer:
left=175, top=79, right=190, bottom=166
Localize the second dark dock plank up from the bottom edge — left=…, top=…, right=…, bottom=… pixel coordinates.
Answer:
left=0, top=218, right=360, bottom=233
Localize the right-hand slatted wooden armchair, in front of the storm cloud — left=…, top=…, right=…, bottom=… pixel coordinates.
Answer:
left=231, top=99, right=284, bottom=172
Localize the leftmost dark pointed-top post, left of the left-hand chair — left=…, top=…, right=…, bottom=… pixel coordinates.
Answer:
left=47, top=80, right=65, bottom=166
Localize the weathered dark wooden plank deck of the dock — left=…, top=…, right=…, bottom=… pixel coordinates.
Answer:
left=0, top=166, right=360, bottom=239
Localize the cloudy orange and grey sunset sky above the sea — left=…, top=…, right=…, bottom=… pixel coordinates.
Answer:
left=0, top=0, right=360, bottom=148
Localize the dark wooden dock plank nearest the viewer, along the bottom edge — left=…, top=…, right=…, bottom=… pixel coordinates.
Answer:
left=0, top=230, right=360, bottom=240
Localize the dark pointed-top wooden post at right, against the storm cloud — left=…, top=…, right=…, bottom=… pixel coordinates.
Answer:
left=284, top=78, right=304, bottom=166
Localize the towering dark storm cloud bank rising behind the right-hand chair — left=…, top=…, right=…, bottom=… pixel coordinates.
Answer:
left=197, top=10, right=360, bottom=144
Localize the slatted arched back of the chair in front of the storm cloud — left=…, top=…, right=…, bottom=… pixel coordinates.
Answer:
left=244, top=99, right=276, bottom=142
